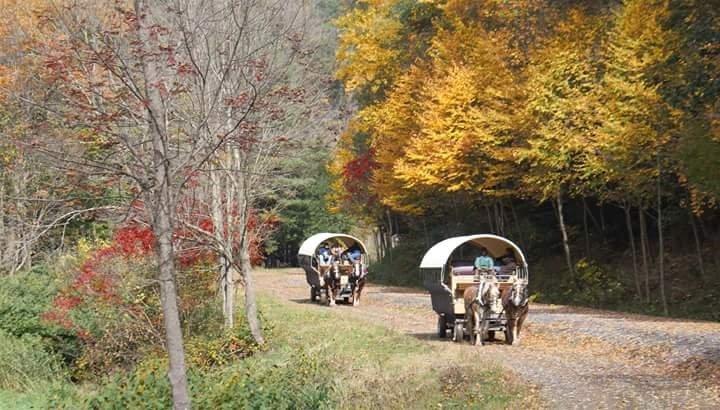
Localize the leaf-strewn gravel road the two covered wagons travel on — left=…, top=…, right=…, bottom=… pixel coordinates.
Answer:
left=256, top=269, right=720, bottom=409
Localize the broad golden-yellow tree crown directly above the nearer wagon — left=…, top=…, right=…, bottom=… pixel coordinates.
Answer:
left=394, top=21, right=516, bottom=199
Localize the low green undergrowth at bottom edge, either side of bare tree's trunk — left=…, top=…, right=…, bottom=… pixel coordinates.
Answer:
left=86, top=351, right=333, bottom=409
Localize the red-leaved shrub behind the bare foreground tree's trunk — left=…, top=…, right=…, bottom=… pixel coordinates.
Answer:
left=44, top=232, right=217, bottom=379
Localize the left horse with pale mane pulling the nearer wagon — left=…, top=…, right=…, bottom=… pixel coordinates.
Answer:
left=463, top=276, right=502, bottom=345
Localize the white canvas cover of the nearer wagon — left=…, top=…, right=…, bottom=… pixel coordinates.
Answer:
left=420, top=234, right=527, bottom=269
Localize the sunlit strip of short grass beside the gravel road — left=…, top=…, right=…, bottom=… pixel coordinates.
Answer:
left=250, top=298, right=525, bottom=409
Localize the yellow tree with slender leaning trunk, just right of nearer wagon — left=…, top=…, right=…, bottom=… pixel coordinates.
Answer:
left=518, top=10, right=600, bottom=279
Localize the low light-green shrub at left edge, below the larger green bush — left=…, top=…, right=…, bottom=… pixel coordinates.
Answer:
left=0, top=330, right=67, bottom=391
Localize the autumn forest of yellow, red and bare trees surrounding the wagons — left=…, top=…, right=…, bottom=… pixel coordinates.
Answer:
left=0, top=0, right=720, bottom=408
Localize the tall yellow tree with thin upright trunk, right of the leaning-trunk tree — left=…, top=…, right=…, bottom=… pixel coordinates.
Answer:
left=598, top=0, right=678, bottom=314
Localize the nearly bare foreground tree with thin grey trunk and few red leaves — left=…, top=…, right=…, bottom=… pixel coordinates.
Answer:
left=31, top=0, right=312, bottom=408
